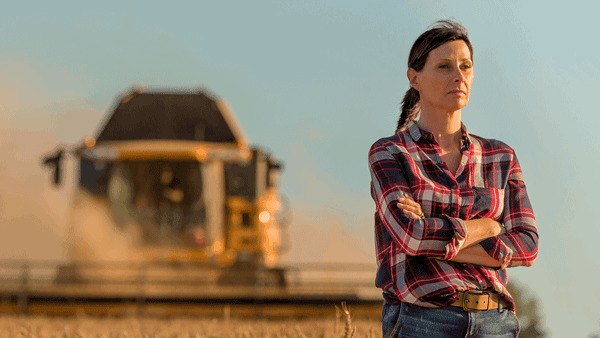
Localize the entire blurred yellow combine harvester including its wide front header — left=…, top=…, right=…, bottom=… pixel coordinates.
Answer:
left=0, top=89, right=381, bottom=317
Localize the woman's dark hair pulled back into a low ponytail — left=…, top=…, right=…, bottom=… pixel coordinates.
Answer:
left=396, top=20, right=473, bottom=132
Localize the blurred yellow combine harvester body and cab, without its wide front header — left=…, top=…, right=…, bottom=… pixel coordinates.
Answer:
left=44, top=89, right=289, bottom=287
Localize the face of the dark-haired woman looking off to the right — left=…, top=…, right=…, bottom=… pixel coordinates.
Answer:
left=407, top=40, right=473, bottom=112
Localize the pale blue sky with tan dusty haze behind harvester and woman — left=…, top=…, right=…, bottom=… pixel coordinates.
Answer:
left=0, top=0, right=600, bottom=337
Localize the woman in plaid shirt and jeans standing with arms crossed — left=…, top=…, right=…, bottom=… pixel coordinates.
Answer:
left=369, top=21, right=538, bottom=337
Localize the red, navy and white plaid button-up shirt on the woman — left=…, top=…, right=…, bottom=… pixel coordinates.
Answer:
left=369, top=122, right=538, bottom=309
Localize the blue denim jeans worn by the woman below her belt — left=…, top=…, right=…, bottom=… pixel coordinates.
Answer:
left=381, top=297, right=519, bottom=338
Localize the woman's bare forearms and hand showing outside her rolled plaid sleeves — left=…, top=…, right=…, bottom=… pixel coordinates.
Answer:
left=397, top=194, right=505, bottom=268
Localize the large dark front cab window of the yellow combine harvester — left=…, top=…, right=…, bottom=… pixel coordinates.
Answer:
left=102, top=161, right=206, bottom=246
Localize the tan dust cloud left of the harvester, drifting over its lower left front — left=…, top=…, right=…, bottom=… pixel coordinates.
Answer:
left=0, top=96, right=141, bottom=261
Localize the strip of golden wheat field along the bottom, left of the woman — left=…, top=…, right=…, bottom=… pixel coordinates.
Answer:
left=0, top=307, right=381, bottom=338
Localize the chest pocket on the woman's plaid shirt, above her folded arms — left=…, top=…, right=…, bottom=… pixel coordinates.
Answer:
left=468, top=187, right=504, bottom=222
